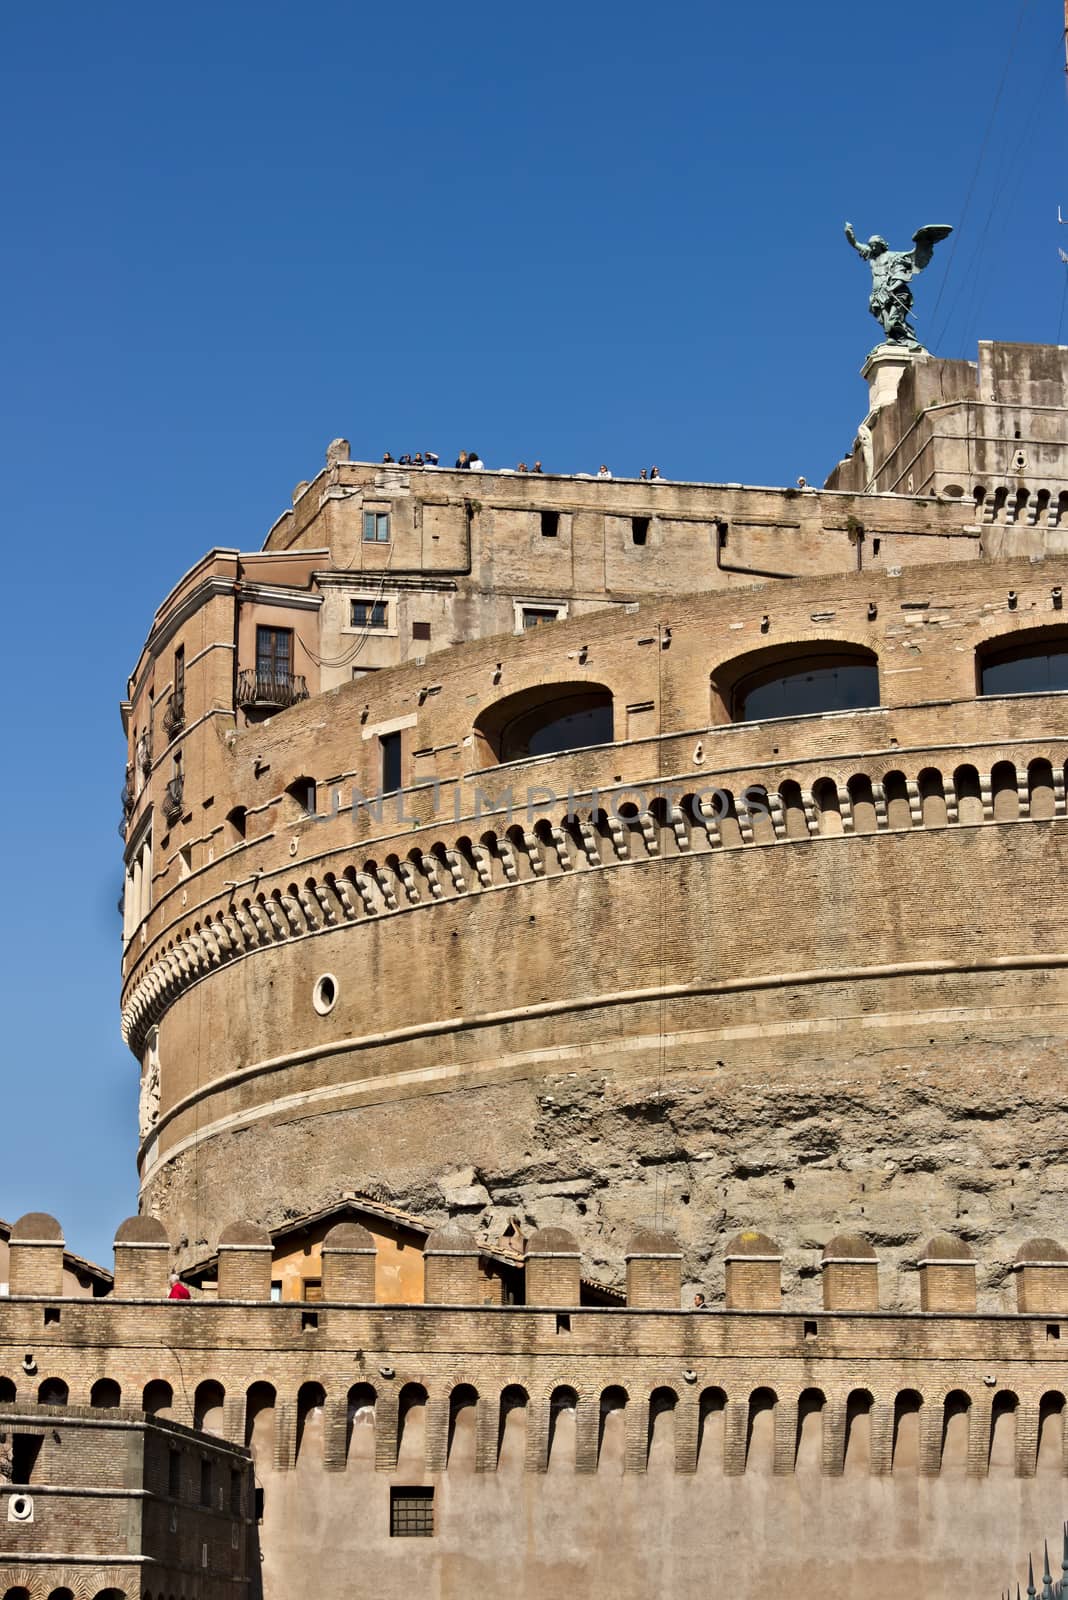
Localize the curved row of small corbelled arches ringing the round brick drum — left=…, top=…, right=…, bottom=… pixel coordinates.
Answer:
left=123, top=754, right=1068, bottom=1051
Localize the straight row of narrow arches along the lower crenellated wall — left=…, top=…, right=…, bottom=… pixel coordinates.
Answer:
left=14, top=1378, right=1068, bottom=1474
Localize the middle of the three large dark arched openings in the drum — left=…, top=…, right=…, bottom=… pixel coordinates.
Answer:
left=713, top=640, right=879, bottom=722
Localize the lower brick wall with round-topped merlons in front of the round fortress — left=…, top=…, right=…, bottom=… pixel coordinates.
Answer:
left=0, top=1219, right=1068, bottom=1600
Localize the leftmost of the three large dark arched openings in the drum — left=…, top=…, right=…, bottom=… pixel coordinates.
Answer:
left=475, top=683, right=616, bottom=762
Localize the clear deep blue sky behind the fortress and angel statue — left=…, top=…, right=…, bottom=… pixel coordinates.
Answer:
left=0, top=0, right=1068, bottom=1262
